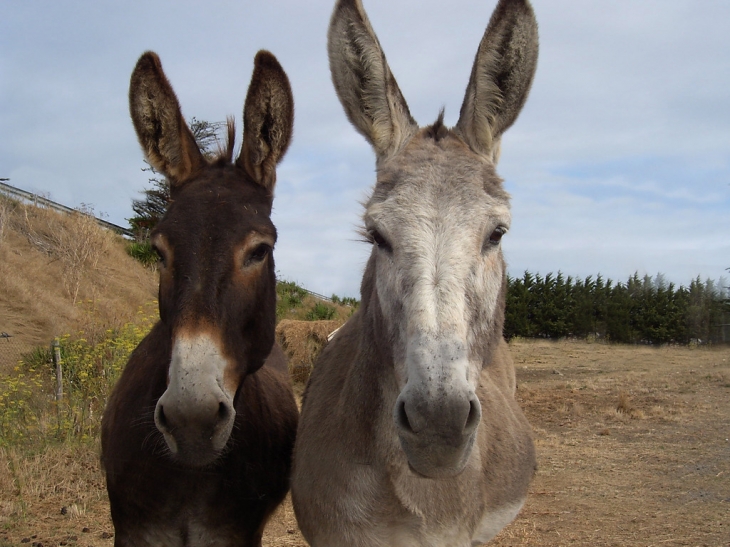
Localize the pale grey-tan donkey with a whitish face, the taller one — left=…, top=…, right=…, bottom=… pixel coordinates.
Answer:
left=292, top=0, right=538, bottom=547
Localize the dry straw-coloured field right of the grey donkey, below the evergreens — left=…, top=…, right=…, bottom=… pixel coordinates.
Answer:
left=493, top=341, right=730, bottom=546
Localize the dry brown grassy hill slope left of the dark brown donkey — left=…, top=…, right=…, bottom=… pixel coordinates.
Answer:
left=0, top=196, right=157, bottom=372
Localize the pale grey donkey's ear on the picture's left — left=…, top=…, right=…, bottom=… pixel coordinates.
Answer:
left=327, top=0, right=418, bottom=159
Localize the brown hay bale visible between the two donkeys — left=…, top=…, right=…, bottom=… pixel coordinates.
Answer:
left=276, top=319, right=342, bottom=383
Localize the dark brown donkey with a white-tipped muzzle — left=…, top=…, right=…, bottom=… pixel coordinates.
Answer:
left=101, top=51, right=298, bottom=547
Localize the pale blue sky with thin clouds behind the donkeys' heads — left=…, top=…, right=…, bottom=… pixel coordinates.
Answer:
left=0, top=0, right=730, bottom=296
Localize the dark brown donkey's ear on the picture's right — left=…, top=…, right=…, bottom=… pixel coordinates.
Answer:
left=236, top=50, right=294, bottom=191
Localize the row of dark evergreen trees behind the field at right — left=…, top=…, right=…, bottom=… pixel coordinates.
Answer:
left=504, top=272, right=730, bottom=344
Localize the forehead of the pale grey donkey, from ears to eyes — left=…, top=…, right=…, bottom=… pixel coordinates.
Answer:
left=365, top=136, right=511, bottom=227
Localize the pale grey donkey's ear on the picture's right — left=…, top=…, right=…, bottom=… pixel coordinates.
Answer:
left=455, top=0, right=538, bottom=161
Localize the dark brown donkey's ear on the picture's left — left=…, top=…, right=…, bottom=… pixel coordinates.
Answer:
left=129, top=51, right=205, bottom=188
